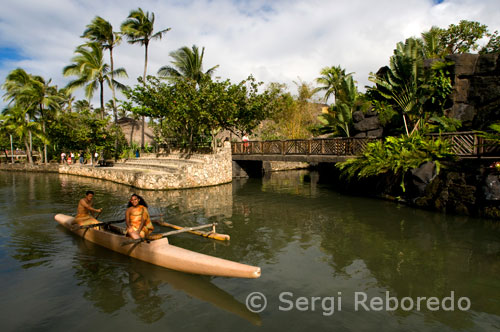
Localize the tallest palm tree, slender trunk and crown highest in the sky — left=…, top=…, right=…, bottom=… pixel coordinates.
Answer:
left=121, top=8, right=170, bottom=148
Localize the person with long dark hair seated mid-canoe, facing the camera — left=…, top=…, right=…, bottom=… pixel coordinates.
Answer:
left=125, top=194, right=154, bottom=239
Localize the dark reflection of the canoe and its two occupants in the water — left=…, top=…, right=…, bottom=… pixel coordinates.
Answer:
left=70, top=228, right=261, bottom=325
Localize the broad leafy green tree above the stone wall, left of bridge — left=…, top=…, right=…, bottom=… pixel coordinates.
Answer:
left=126, top=76, right=272, bottom=146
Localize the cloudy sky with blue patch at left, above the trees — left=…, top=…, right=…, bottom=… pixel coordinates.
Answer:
left=0, top=0, right=500, bottom=108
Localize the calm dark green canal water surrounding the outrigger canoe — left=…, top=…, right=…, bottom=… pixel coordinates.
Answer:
left=0, top=171, right=500, bottom=331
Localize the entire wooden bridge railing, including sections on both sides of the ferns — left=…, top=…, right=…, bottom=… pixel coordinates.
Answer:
left=231, top=132, right=500, bottom=157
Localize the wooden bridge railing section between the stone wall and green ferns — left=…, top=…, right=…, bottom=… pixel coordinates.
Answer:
left=231, top=137, right=380, bottom=156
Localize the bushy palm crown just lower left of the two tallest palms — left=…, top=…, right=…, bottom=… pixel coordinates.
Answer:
left=63, top=43, right=128, bottom=119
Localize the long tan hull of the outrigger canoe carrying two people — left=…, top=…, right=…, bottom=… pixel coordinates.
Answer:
left=54, top=214, right=260, bottom=278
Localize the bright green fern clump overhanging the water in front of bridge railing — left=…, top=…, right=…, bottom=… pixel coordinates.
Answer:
left=336, top=134, right=454, bottom=191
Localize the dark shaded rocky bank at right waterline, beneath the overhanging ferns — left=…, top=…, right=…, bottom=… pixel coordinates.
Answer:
left=315, top=160, right=500, bottom=220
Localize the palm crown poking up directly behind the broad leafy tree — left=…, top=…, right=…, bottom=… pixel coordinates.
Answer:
left=158, top=45, right=219, bottom=85
